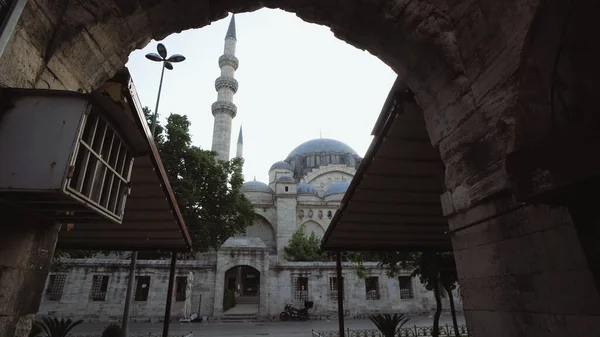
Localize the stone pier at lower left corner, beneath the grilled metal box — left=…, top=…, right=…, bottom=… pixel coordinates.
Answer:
left=0, top=207, right=60, bottom=337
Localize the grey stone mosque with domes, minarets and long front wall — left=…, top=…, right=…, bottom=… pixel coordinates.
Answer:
left=39, top=16, right=462, bottom=321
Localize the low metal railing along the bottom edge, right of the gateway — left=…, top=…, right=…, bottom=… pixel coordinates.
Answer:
left=312, top=324, right=469, bottom=337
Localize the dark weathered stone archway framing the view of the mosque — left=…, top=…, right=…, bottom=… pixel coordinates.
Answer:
left=0, top=0, right=600, bottom=336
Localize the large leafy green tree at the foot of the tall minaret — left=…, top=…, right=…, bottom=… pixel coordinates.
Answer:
left=144, top=108, right=254, bottom=251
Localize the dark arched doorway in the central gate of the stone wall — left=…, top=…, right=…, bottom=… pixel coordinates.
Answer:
left=223, top=265, right=260, bottom=314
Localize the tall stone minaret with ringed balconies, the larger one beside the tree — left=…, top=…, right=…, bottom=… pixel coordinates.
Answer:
left=212, top=15, right=239, bottom=160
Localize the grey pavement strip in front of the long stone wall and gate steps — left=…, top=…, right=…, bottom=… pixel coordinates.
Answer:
left=72, top=315, right=465, bottom=337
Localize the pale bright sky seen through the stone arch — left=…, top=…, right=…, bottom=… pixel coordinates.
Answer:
left=127, top=9, right=396, bottom=182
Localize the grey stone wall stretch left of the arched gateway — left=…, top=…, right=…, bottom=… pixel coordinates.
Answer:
left=38, top=259, right=215, bottom=322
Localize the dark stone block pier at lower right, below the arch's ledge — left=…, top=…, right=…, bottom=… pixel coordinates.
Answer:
left=440, top=185, right=600, bottom=337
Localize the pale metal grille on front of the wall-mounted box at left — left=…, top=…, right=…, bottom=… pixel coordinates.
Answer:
left=66, top=109, right=133, bottom=222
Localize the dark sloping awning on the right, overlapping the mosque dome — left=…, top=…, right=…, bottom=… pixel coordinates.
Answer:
left=321, top=79, right=452, bottom=251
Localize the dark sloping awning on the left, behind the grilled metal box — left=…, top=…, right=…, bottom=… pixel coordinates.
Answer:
left=57, top=68, right=192, bottom=252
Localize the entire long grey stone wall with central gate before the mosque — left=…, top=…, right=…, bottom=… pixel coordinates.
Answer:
left=38, top=258, right=462, bottom=322
